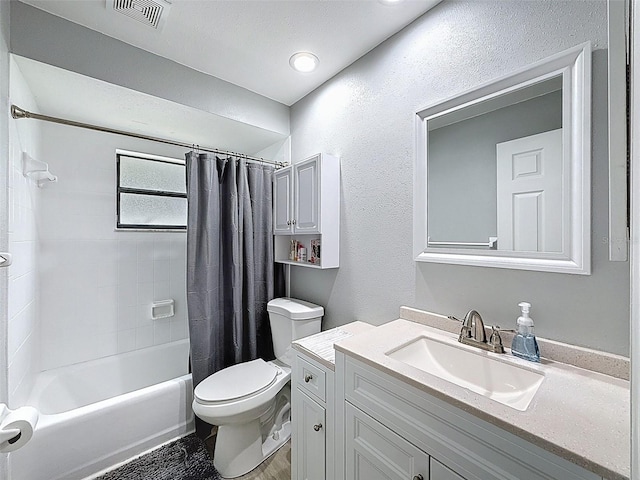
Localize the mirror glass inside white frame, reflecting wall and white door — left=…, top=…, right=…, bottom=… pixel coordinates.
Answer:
left=427, top=76, right=566, bottom=252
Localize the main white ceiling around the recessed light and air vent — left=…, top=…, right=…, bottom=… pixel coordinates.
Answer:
left=21, top=0, right=440, bottom=105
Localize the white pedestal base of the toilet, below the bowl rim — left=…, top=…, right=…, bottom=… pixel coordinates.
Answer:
left=213, top=419, right=291, bottom=478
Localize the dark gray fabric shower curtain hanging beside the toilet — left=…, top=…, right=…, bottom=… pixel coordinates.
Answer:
left=186, top=152, right=274, bottom=433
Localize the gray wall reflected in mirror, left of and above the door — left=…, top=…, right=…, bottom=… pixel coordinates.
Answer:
left=427, top=90, right=562, bottom=245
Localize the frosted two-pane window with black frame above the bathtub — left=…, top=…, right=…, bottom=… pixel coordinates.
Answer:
left=116, top=152, right=187, bottom=230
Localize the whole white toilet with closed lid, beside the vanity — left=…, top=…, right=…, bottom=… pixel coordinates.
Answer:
left=193, top=298, right=324, bottom=478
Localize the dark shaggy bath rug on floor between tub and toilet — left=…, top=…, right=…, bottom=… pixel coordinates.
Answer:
left=96, top=434, right=222, bottom=480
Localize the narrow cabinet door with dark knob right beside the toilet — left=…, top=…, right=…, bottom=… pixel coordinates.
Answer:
left=292, top=389, right=326, bottom=480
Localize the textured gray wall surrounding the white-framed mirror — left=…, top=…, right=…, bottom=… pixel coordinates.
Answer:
left=291, top=0, right=629, bottom=354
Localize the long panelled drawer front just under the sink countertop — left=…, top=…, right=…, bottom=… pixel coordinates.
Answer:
left=344, top=356, right=601, bottom=480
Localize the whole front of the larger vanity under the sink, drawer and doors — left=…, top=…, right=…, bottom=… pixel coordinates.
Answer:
left=336, top=352, right=602, bottom=480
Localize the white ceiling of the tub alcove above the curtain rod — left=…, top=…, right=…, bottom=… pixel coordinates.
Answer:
left=13, top=55, right=284, bottom=154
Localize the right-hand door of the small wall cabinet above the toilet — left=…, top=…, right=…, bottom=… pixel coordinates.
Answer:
left=293, top=156, right=320, bottom=233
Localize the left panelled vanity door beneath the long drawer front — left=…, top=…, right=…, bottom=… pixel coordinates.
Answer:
left=345, top=403, right=429, bottom=480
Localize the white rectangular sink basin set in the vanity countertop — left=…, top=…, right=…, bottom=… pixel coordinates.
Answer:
left=386, top=336, right=544, bottom=411
